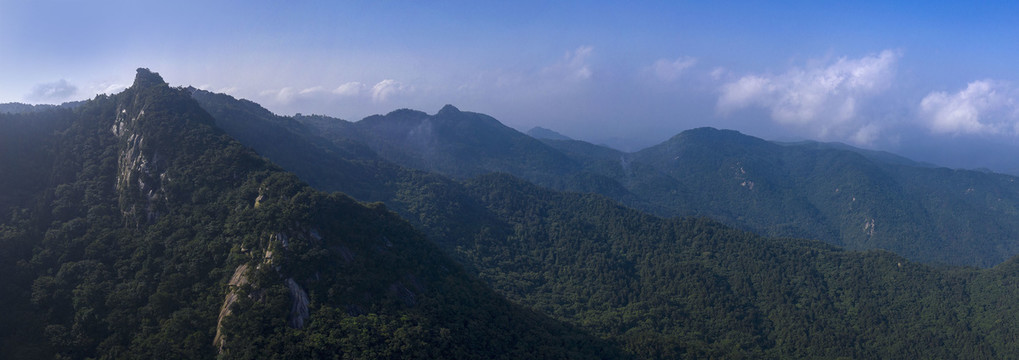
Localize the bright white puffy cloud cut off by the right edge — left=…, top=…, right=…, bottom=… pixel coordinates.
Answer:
left=920, top=80, right=1019, bottom=135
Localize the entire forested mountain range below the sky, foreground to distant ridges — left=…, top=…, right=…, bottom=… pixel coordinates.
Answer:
left=0, top=69, right=1019, bottom=359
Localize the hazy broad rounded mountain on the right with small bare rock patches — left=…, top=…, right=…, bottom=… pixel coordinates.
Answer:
left=633, top=128, right=1019, bottom=267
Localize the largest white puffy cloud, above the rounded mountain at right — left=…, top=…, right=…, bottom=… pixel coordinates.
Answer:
left=717, top=50, right=900, bottom=140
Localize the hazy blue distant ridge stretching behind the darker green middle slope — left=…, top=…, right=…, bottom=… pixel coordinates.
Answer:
left=296, top=106, right=1019, bottom=267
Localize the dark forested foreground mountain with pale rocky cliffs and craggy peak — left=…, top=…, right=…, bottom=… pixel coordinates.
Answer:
left=0, top=69, right=620, bottom=359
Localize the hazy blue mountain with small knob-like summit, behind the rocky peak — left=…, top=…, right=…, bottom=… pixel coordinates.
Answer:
left=296, top=105, right=636, bottom=201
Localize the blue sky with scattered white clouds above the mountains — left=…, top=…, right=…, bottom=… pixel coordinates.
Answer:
left=0, top=0, right=1019, bottom=170
